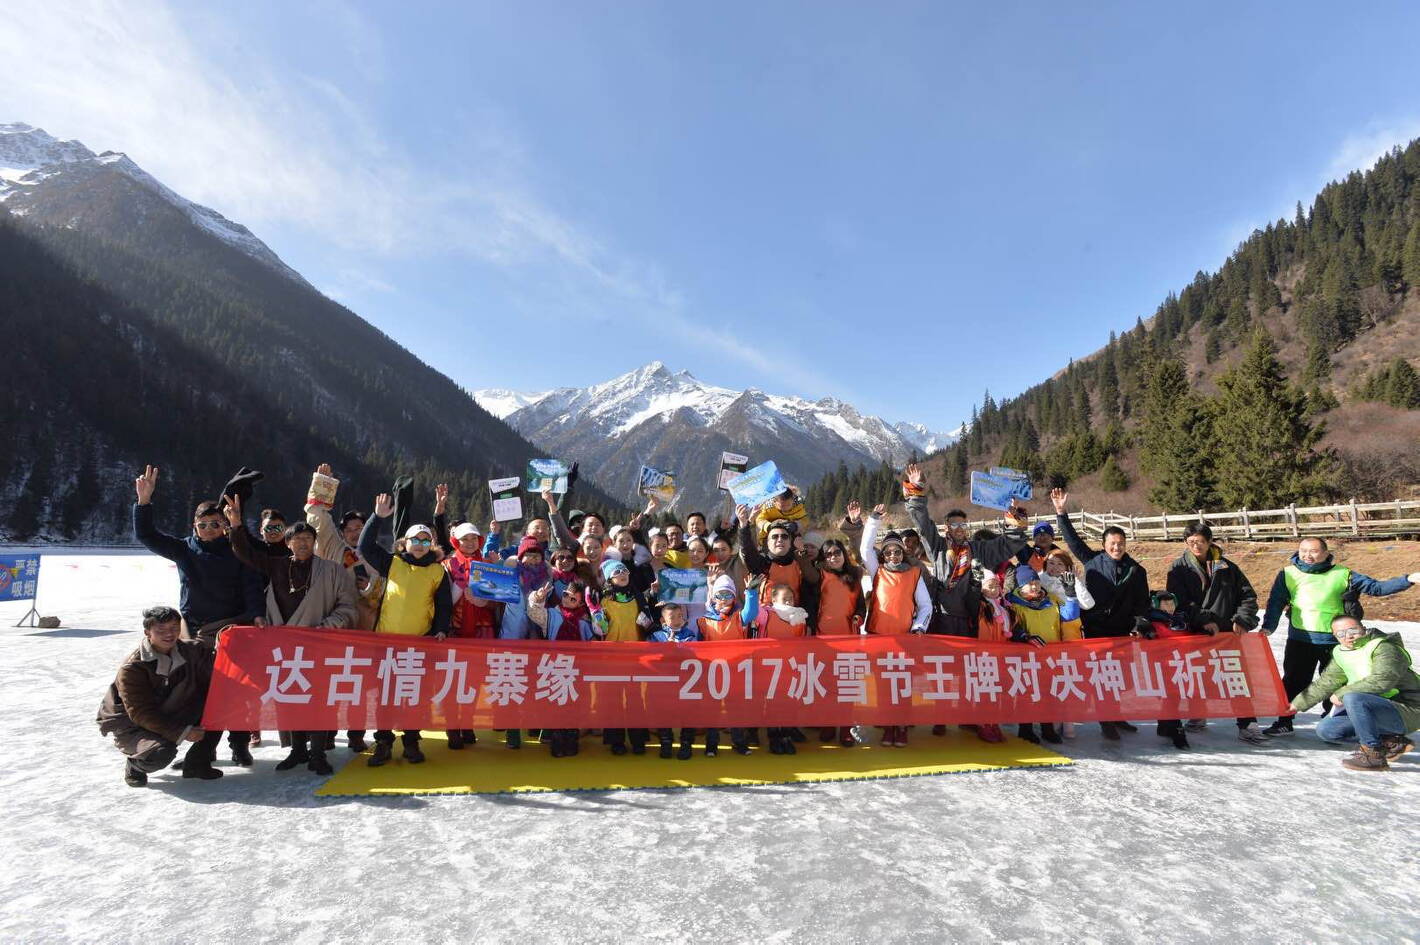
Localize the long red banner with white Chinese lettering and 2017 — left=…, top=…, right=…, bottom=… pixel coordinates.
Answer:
left=203, top=627, right=1287, bottom=730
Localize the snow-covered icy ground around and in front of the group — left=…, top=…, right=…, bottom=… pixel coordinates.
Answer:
left=0, top=553, right=1420, bottom=944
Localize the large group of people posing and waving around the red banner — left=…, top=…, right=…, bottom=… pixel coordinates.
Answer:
left=98, top=463, right=1420, bottom=786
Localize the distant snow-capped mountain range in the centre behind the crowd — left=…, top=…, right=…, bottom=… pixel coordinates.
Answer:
left=473, top=361, right=959, bottom=507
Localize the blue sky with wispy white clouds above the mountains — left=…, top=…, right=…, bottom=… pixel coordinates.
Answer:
left=0, top=0, right=1420, bottom=428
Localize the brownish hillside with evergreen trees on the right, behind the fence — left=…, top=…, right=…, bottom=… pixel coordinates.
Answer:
left=818, top=141, right=1420, bottom=512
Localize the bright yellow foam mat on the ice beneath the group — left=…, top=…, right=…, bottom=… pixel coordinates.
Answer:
left=315, top=728, right=1072, bottom=797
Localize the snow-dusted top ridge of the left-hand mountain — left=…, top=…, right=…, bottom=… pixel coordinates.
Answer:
left=0, top=122, right=305, bottom=284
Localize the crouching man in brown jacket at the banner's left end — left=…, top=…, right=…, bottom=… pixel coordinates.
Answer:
left=98, top=607, right=222, bottom=787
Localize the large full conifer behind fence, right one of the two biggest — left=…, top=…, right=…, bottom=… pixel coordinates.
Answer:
left=1211, top=328, right=1329, bottom=509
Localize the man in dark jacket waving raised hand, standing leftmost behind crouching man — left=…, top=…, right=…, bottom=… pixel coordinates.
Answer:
left=133, top=466, right=266, bottom=767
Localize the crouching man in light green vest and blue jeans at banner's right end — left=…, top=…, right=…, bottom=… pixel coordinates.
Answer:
left=1292, top=615, right=1420, bottom=772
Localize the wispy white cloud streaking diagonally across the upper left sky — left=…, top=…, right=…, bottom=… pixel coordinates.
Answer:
left=0, top=0, right=832, bottom=391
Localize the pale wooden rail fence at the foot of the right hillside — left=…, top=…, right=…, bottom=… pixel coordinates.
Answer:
left=967, top=499, right=1420, bottom=541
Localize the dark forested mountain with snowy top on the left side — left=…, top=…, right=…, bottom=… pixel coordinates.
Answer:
left=0, top=124, right=619, bottom=541
